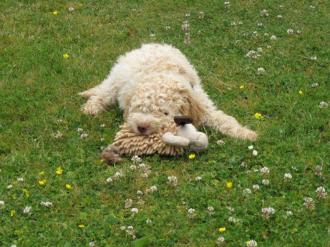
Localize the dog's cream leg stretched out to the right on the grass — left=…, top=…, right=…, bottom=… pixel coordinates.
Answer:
left=194, top=86, right=258, bottom=141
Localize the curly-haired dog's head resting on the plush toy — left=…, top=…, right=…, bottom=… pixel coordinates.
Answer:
left=125, top=89, right=203, bottom=135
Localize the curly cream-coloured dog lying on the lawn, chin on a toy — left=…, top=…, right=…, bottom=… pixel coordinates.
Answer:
left=80, top=44, right=257, bottom=140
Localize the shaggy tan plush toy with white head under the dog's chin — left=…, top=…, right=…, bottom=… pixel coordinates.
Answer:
left=101, top=117, right=208, bottom=165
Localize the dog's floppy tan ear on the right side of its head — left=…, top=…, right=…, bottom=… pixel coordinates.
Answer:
left=180, top=89, right=205, bottom=126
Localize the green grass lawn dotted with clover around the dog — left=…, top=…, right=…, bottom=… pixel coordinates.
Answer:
left=0, top=0, right=330, bottom=247
